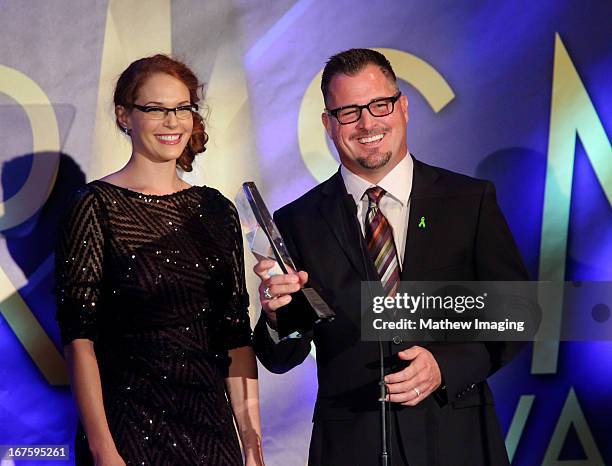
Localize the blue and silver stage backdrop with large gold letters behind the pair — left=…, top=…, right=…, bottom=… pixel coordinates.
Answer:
left=0, top=0, right=612, bottom=466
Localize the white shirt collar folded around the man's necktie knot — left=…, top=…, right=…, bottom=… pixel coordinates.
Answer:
left=340, top=153, right=414, bottom=206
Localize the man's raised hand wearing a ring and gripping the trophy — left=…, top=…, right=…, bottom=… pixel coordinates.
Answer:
left=253, top=259, right=308, bottom=328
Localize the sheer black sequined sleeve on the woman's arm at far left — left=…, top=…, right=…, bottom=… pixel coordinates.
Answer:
left=55, top=188, right=104, bottom=345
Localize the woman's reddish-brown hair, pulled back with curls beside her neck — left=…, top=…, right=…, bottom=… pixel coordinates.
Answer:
left=113, top=54, right=208, bottom=172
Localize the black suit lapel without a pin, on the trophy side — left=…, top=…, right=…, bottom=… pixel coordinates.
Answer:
left=319, top=171, right=378, bottom=280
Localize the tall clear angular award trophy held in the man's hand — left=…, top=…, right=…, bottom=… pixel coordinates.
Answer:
left=236, top=181, right=335, bottom=339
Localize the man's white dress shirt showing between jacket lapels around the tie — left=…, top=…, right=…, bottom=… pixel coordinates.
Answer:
left=340, top=153, right=414, bottom=269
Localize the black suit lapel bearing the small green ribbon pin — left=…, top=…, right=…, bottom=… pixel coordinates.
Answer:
left=401, top=159, right=442, bottom=280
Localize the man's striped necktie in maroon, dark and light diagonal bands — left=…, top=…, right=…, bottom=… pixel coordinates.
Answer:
left=365, top=186, right=400, bottom=296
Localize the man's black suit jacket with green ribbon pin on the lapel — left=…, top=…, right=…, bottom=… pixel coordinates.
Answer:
left=254, top=160, right=528, bottom=466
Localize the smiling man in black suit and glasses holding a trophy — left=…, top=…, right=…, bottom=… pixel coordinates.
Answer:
left=254, top=49, right=527, bottom=466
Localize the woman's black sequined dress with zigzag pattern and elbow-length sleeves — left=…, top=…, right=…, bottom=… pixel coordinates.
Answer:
left=56, top=181, right=251, bottom=466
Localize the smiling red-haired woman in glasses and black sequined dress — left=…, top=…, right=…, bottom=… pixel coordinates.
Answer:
left=56, top=55, right=263, bottom=466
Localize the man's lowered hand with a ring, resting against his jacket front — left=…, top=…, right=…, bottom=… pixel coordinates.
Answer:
left=385, top=346, right=442, bottom=406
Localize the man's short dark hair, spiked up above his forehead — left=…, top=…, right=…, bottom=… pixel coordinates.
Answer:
left=321, top=49, right=397, bottom=102
